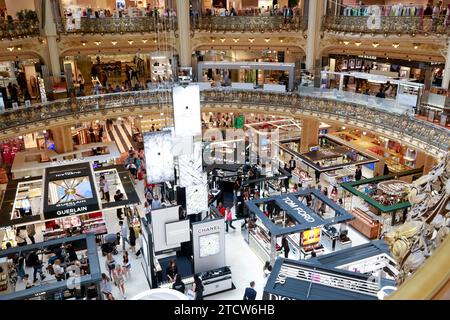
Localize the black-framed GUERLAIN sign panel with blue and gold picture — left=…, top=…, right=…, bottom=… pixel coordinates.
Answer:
left=43, top=162, right=100, bottom=220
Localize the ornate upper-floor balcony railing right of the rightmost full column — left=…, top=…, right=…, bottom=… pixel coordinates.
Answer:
left=322, top=16, right=449, bottom=35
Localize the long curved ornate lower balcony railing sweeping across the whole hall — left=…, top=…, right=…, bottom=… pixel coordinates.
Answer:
left=0, top=90, right=450, bottom=153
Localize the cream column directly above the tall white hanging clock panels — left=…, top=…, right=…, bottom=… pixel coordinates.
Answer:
left=177, top=0, right=192, bottom=67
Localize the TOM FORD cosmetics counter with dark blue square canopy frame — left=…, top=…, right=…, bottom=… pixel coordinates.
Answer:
left=245, top=189, right=354, bottom=262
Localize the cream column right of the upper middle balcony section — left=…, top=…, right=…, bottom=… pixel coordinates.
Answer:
left=306, top=0, right=323, bottom=71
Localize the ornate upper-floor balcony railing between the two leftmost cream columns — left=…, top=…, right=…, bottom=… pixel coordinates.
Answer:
left=64, top=17, right=178, bottom=34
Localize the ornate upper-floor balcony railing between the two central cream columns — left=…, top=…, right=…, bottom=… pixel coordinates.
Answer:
left=191, top=16, right=307, bottom=33
